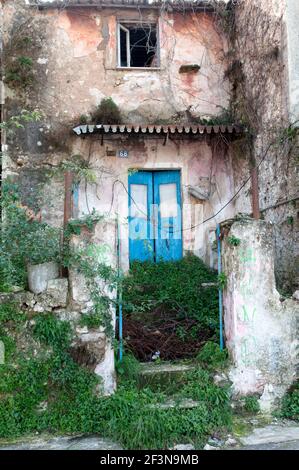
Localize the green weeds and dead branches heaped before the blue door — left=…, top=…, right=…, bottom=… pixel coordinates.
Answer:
left=123, top=255, right=218, bottom=361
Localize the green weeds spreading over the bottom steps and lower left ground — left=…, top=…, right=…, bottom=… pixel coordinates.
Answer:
left=0, top=309, right=231, bottom=449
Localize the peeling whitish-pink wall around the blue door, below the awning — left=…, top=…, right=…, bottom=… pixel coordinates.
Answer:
left=73, top=136, right=234, bottom=270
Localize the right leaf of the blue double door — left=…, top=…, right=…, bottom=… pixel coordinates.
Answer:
left=154, top=171, right=182, bottom=261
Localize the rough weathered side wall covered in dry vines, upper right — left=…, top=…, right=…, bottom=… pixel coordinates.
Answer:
left=231, top=0, right=299, bottom=292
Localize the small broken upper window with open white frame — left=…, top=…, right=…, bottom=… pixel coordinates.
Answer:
left=118, top=23, right=158, bottom=67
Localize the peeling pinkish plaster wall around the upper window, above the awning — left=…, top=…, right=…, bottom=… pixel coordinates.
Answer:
left=4, top=1, right=229, bottom=127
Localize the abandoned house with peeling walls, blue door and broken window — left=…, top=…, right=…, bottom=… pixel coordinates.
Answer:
left=2, top=0, right=299, bottom=407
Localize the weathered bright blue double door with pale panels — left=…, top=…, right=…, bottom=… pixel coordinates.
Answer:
left=128, top=171, right=182, bottom=262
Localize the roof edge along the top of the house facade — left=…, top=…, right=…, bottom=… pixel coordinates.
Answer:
left=29, top=0, right=218, bottom=13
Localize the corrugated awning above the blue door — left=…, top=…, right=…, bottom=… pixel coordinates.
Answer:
left=73, top=124, right=244, bottom=137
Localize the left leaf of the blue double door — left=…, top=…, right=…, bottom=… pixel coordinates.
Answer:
left=129, top=171, right=154, bottom=261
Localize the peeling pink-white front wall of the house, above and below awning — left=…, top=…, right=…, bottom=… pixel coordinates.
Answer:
left=4, top=0, right=234, bottom=266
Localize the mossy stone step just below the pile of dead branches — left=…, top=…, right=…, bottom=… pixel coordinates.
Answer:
left=139, top=363, right=196, bottom=392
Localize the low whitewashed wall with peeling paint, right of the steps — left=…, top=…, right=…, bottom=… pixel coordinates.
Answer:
left=223, top=219, right=299, bottom=411
